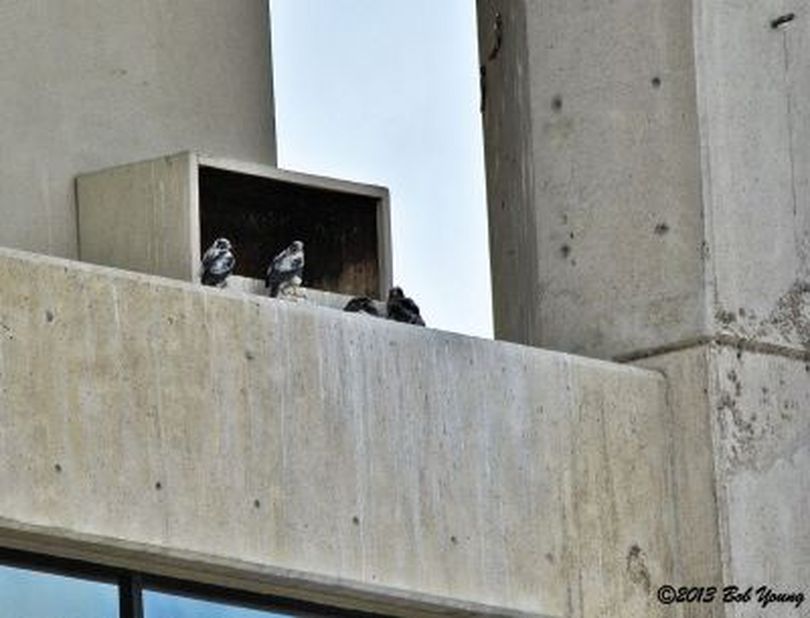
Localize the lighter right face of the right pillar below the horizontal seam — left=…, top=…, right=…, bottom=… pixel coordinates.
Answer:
left=711, top=347, right=810, bottom=618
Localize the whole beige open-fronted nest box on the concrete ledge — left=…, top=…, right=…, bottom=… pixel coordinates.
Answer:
left=76, top=152, right=391, bottom=298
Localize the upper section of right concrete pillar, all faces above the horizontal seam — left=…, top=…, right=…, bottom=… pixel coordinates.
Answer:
left=478, top=0, right=810, bottom=358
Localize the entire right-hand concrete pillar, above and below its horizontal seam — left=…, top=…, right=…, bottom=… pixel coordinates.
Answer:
left=478, top=0, right=810, bottom=616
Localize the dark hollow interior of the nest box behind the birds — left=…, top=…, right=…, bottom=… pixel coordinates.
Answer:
left=198, top=164, right=390, bottom=298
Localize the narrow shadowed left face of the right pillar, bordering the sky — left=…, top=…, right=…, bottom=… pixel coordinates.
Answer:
left=477, top=0, right=541, bottom=344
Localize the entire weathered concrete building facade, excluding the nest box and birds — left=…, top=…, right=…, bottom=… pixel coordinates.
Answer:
left=0, top=0, right=810, bottom=618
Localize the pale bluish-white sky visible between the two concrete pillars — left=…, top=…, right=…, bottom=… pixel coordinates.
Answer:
left=270, top=0, right=492, bottom=337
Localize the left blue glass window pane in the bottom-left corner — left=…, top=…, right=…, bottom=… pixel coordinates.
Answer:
left=0, top=565, right=118, bottom=618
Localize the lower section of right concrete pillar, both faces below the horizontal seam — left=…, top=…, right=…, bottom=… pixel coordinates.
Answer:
left=643, top=344, right=810, bottom=617
